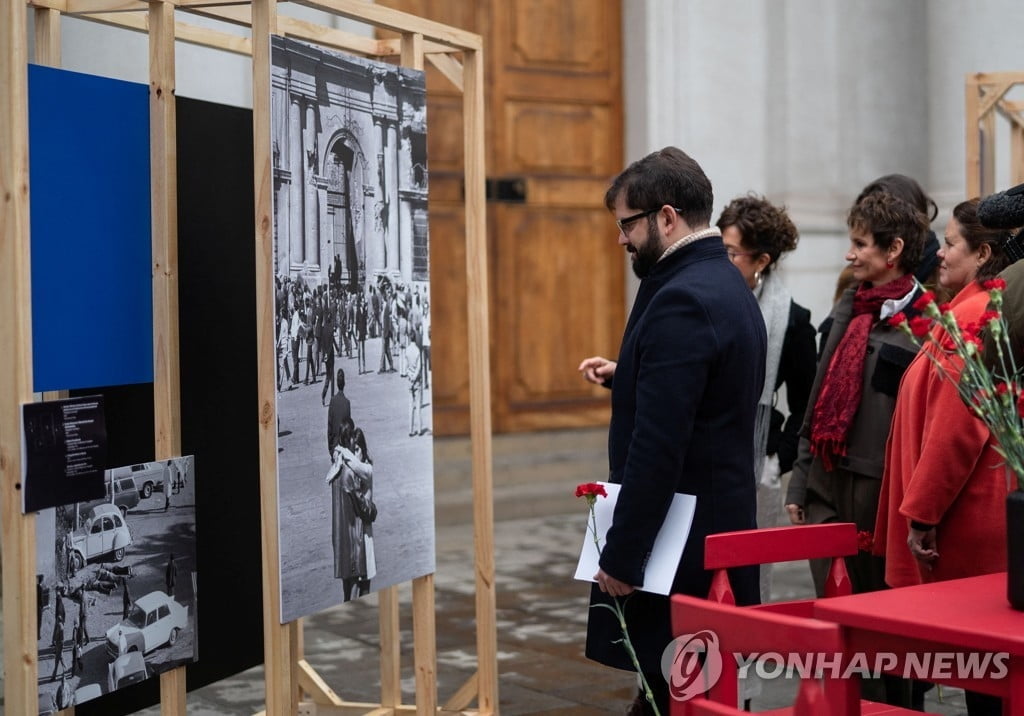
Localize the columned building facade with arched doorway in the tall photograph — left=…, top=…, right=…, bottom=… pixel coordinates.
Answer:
left=272, top=37, right=428, bottom=284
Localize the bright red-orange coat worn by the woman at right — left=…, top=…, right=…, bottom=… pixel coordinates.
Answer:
left=873, top=282, right=1010, bottom=587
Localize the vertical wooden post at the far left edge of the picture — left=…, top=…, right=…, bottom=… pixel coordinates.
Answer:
left=0, top=0, right=39, bottom=714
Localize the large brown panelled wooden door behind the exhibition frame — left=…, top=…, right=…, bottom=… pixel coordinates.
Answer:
left=379, top=0, right=626, bottom=434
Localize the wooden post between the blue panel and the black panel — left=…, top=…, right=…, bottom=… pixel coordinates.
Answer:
left=148, top=0, right=185, bottom=716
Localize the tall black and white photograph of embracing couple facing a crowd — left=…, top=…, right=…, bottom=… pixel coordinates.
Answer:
left=270, top=37, right=434, bottom=623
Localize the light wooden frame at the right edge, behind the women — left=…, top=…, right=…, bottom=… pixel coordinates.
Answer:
left=965, top=72, right=1024, bottom=197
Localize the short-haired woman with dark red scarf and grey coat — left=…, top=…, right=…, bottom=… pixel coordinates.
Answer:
left=785, top=194, right=928, bottom=594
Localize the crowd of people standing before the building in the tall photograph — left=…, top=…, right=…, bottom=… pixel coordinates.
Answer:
left=275, top=257, right=430, bottom=436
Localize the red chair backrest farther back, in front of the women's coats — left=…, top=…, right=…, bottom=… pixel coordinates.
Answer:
left=705, top=522, right=857, bottom=615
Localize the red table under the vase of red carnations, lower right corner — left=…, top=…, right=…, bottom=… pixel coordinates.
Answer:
left=814, top=573, right=1024, bottom=715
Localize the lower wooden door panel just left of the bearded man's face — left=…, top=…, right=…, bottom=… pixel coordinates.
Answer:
left=493, top=205, right=622, bottom=429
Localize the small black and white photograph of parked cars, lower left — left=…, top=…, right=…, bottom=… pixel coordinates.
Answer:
left=36, top=456, right=198, bottom=713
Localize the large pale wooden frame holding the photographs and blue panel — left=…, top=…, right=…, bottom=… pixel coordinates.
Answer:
left=0, top=0, right=498, bottom=716
